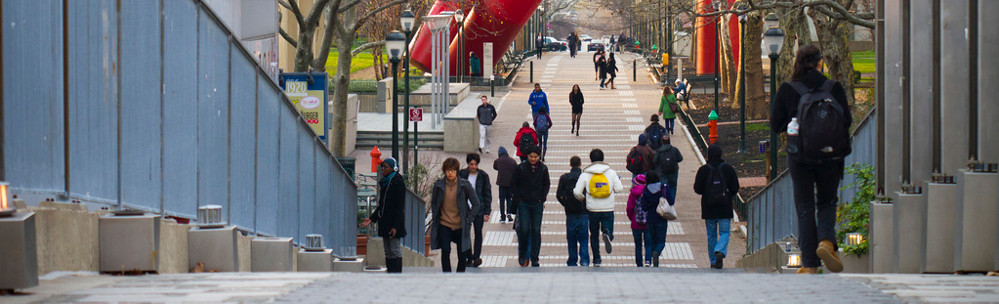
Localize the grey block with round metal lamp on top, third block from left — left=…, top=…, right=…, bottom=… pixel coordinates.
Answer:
left=187, top=226, right=239, bottom=272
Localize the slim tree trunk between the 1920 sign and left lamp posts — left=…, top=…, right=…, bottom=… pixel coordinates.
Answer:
left=330, top=33, right=356, bottom=156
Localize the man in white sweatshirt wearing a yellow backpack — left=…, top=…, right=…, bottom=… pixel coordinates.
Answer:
left=572, top=149, right=624, bottom=267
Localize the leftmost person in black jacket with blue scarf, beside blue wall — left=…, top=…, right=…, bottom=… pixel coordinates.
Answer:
left=361, top=157, right=406, bottom=273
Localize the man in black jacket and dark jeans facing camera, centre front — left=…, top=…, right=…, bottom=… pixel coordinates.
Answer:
left=513, top=146, right=552, bottom=267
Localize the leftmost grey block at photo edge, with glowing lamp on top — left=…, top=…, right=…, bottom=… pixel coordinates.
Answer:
left=0, top=212, right=38, bottom=289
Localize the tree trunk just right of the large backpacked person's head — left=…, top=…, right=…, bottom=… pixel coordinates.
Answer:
left=810, top=0, right=854, bottom=106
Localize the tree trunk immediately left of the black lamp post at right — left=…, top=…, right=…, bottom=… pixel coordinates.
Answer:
left=746, top=11, right=770, bottom=119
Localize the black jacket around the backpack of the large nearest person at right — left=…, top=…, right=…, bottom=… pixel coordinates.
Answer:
left=770, top=69, right=853, bottom=160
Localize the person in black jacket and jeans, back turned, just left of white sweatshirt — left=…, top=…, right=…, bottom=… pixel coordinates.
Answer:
left=555, top=155, right=590, bottom=267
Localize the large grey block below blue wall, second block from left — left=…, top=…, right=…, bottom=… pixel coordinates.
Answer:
left=98, top=214, right=160, bottom=273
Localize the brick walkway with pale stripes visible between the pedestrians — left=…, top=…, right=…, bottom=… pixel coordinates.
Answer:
left=472, top=53, right=745, bottom=268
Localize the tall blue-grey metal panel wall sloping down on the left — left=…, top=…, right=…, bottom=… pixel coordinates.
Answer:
left=0, top=0, right=357, bottom=256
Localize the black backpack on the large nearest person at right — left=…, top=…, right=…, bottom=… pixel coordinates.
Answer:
left=788, top=79, right=850, bottom=158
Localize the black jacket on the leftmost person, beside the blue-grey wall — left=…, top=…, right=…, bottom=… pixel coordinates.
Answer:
left=368, top=173, right=406, bottom=238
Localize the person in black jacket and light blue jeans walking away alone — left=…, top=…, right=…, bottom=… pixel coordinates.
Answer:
left=694, top=145, right=739, bottom=269
